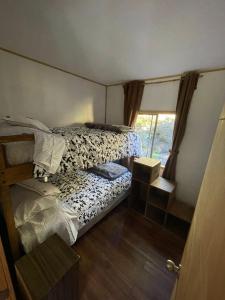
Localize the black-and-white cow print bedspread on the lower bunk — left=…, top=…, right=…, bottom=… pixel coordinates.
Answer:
left=49, top=170, right=131, bottom=228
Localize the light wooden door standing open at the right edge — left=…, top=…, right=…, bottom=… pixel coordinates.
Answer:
left=174, top=103, right=225, bottom=300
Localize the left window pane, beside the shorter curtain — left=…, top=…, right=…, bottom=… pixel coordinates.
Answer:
left=135, top=114, right=156, bottom=157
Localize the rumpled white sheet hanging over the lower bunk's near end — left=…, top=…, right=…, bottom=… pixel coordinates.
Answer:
left=11, top=185, right=78, bottom=253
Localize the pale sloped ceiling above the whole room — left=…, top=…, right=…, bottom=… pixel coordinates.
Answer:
left=0, top=0, right=225, bottom=83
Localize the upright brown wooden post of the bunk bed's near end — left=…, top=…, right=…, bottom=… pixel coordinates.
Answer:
left=0, top=144, right=21, bottom=261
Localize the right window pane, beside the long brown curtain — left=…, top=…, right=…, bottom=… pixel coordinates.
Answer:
left=152, top=114, right=175, bottom=166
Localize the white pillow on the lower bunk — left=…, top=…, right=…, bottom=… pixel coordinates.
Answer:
left=17, top=178, right=61, bottom=197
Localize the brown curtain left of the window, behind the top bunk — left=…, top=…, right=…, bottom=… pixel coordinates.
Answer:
left=123, top=80, right=145, bottom=127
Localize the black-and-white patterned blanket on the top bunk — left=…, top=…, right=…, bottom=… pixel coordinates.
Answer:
left=34, top=127, right=140, bottom=177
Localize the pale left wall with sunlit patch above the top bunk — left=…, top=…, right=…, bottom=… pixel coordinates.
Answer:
left=0, top=50, right=105, bottom=126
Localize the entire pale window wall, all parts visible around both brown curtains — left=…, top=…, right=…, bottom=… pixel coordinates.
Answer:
left=107, top=71, right=225, bottom=205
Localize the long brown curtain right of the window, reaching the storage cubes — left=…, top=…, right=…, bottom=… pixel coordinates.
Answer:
left=162, top=72, right=199, bottom=181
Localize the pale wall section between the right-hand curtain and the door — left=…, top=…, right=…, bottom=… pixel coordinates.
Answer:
left=177, top=71, right=225, bottom=204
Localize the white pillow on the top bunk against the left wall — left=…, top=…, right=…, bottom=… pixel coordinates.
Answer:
left=3, top=116, right=51, bottom=132
